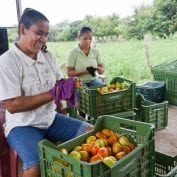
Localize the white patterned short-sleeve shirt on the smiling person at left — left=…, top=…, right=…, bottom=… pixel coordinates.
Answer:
left=0, top=45, right=63, bottom=136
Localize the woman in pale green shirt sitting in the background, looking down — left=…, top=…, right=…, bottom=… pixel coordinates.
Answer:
left=66, top=27, right=104, bottom=87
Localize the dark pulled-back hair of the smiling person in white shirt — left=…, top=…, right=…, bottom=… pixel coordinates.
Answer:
left=18, top=8, right=49, bottom=52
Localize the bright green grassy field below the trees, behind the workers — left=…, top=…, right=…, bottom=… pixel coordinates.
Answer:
left=45, top=38, right=177, bottom=83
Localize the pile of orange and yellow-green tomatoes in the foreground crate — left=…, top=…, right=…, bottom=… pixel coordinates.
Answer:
left=60, top=128, right=135, bottom=167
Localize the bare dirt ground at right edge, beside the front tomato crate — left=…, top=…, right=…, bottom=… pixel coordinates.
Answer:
left=155, top=105, right=177, bottom=156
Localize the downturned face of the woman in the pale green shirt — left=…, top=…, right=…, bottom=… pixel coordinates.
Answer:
left=79, top=32, right=93, bottom=48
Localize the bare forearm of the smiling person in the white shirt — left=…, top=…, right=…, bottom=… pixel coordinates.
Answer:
left=3, top=92, right=54, bottom=114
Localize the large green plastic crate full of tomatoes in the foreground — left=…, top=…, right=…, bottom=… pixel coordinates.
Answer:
left=39, top=115, right=154, bottom=177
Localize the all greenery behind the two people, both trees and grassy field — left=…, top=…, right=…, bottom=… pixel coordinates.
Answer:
left=8, top=0, right=177, bottom=83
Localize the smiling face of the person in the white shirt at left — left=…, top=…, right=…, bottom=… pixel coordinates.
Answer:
left=23, top=21, right=49, bottom=53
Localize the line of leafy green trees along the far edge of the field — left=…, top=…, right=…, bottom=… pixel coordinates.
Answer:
left=9, top=0, right=177, bottom=42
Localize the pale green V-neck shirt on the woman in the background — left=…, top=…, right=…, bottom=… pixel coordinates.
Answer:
left=66, top=46, right=101, bottom=81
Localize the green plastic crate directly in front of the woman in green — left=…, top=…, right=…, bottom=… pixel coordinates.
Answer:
left=79, top=77, right=135, bottom=118
